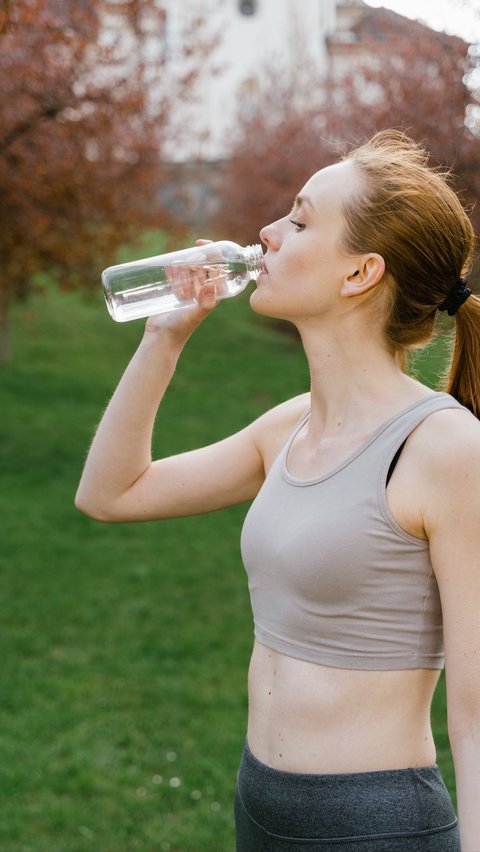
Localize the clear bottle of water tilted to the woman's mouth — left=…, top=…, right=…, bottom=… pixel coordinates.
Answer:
left=102, top=240, right=264, bottom=322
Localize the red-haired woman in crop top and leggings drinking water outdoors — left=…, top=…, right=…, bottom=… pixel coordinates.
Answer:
left=77, top=131, right=480, bottom=852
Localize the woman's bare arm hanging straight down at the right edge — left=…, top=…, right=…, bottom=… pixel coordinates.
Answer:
left=424, top=411, right=480, bottom=852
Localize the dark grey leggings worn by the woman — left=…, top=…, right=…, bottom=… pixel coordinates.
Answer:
left=235, top=744, right=460, bottom=852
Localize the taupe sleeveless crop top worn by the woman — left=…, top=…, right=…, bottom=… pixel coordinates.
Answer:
left=241, top=393, right=462, bottom=670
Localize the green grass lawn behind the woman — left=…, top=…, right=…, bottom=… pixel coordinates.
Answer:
left=0, top=276, right=453, bottom=852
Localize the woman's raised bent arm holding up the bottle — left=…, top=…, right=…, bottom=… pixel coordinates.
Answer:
left=75, top=285, right=308, bottom=522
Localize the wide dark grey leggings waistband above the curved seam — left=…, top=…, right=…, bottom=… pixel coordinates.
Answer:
left=238, top=742, right=456, bottom=848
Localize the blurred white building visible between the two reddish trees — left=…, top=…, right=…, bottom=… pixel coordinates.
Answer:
left=162, top=0, right=368, bottom=161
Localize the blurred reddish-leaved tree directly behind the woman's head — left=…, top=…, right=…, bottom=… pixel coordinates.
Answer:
left=215, top=9, right=480, bottom=270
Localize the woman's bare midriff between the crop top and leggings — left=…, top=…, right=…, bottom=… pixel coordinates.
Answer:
left=247, top=642, right=439, bottom=773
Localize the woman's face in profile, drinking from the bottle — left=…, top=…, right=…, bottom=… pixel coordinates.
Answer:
left=251, top=161, right=360, bottom=320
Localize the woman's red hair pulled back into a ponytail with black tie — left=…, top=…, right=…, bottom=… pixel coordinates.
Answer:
left=343, top=130, right=480, bottom=416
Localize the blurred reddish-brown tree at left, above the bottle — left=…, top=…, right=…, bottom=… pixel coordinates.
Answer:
left=0, top=0, right=218, bottom=360
